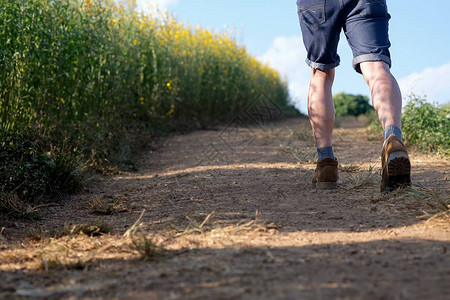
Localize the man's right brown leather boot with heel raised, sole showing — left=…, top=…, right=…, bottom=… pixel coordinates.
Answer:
left=380, top=135, right=411, bottom=193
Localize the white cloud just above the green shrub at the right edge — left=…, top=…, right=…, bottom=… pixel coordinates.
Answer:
left=398, top=62, right=450, bottom=104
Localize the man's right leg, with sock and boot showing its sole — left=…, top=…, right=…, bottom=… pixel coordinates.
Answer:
left=360, top=61, right=411, bottom=192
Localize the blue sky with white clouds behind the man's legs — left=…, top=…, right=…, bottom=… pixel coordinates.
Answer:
left=137, top=0, right=450, bottom=112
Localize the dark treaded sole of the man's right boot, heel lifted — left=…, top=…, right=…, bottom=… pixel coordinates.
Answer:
left=384, top=152, right=411, bottom=192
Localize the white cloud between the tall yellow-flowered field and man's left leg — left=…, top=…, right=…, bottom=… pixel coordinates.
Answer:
left=258, top=36, right=311, bottom=113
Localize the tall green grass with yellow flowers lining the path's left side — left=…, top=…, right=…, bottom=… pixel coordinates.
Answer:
left=0, top=0, right=289, bottom=206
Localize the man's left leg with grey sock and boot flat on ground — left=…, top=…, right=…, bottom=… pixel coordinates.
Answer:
left=308, top=69, right=338, bottom=189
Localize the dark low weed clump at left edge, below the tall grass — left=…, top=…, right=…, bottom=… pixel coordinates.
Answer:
left=0, top=128, right=83, bottom=219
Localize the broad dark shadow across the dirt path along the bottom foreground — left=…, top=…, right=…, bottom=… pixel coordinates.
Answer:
left=0, top=239, right=450, bottom=299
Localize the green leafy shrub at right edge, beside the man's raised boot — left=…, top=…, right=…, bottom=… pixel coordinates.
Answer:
left=402, top=95, right=450, bottom=156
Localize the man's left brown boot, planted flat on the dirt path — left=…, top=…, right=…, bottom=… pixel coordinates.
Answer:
left=313, top=158, right=339, bottom=190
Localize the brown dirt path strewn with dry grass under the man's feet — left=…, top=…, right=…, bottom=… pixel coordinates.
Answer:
left=0, top=120, right=450, bottom=299
